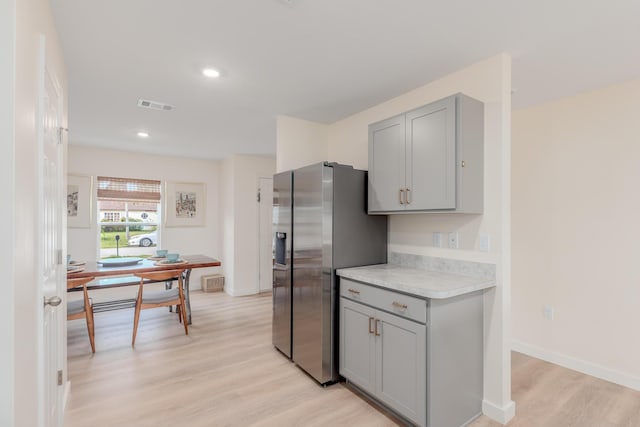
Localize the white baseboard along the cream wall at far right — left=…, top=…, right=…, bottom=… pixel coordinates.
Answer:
left=511, top=341, right=640, bottom=391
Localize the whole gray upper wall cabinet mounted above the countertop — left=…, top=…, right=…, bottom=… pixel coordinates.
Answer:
left=368, top=94, right=484, bottom=214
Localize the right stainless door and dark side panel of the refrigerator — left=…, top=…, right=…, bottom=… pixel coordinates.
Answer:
left=288, top=163, right=387, bottom=384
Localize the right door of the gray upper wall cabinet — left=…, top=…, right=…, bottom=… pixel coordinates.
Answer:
left=406, top=96, right=456, bottom=210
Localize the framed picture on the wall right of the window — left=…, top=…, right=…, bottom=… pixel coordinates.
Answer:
left=164, top=182, right=206, bottom=227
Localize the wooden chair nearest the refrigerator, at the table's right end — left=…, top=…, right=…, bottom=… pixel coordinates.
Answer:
left=131, top=268, right=189, bottom=347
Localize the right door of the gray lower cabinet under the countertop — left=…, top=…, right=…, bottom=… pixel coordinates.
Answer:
left=374, top=311, right=427, bottom=426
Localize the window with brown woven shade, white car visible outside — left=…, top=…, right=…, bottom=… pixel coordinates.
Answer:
left=97, top=176, right=160, bottom=258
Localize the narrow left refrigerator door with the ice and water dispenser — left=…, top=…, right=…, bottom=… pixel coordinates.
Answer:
left=272, top=172, right=293, bottom=358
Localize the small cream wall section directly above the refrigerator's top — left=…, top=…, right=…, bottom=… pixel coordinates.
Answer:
left=276, top=116, right=328, bottom=172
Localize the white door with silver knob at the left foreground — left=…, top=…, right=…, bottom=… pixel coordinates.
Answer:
left=37, top=37, right=66, bottom=427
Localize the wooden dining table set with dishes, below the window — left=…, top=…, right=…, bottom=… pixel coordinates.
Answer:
left=67, top=255, right=221, bottom=324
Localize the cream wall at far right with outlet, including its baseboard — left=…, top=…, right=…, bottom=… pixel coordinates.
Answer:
left=512, top=80, right=640, bottom=390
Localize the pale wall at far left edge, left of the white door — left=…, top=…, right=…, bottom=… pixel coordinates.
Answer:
left=0, top=0, right=67, bottom=426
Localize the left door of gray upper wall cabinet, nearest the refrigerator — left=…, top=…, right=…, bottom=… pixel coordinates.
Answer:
left=368, top=114, right=405, bottom=212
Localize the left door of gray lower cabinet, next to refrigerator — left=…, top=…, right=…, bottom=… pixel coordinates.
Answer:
left=340, top=298, right=375, bottom=393
